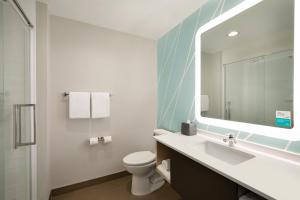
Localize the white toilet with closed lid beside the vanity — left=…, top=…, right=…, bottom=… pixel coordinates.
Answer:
left=123, top=151, right=165, bottom=196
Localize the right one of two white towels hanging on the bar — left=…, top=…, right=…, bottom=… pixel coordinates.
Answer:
left=91, top=92, right=110, bottom=118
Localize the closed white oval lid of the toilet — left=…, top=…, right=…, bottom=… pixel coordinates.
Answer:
left=123, top=151, right=156, bottom=165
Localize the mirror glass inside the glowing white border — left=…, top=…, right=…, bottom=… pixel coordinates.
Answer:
left=201, top=0, right=294, bottom=128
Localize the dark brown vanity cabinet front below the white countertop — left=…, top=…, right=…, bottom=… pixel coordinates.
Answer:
left=157, top=143, right=238, bottom=200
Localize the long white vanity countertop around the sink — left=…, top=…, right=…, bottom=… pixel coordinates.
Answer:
left=154, top=131, right=300, bottom=200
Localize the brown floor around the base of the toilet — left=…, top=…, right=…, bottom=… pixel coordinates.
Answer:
left=52, top=176, right=181, bottom=200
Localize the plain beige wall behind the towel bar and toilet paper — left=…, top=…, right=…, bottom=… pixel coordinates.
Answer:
left=48, top=16, right=156, bottom=188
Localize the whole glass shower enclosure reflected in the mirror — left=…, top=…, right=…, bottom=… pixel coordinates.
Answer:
left=223, top=50, right=294, bottom=126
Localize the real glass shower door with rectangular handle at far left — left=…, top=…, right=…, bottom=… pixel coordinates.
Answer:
left=0, top=0, right=35, bottom=200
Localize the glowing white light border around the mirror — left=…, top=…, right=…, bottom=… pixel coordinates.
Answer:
left=195, top=0, right=300, bottom=141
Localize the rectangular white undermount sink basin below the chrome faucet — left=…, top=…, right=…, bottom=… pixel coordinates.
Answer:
left=193, top=141, right=255, bottom=165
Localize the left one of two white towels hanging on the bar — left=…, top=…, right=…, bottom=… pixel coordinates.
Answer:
left=69, top=92, right=91, bottom=119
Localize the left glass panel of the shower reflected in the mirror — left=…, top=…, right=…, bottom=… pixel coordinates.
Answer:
left=224, top=57, right=265, bottom=124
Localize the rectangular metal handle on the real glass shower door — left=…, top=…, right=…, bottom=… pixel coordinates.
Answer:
left=14, top=104, right=36, bottom=149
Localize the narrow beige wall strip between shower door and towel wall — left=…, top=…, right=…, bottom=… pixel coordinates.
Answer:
left=36, top=2, right=50, bottom=200
